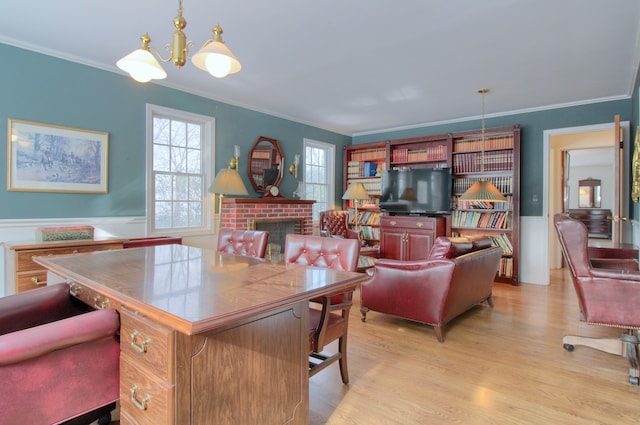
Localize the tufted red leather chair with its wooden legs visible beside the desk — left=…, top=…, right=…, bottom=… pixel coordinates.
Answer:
left=284, top=234, right=360, bottom=384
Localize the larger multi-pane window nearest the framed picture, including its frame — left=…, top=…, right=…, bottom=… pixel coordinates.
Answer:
left=147, top=105, right=215, bottom=235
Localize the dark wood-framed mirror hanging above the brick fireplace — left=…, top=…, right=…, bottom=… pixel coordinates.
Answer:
left=248, top=136, right=283, bottom=192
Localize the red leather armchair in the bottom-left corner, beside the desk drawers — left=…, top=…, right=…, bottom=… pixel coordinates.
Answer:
left=0, top=284, right=120, bottom=424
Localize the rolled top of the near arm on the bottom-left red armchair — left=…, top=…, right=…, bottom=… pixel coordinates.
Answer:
left=0, top=308, right=120, bottom=366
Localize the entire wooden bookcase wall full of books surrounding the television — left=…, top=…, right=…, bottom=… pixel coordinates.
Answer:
left=343, top=125, right=520, bottom=285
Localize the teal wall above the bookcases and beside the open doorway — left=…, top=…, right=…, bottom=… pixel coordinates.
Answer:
left=353, top=98, right=639, bottom=217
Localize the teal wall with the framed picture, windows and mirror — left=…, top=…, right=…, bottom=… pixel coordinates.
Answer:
left=0, top=44, right=351, bottom=219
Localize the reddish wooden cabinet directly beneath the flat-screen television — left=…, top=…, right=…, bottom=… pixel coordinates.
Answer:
left=380, top=216, right=447, bottom=260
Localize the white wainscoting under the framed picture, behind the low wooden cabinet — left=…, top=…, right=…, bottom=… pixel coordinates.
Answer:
left=0, top=217, right=215, bottom=296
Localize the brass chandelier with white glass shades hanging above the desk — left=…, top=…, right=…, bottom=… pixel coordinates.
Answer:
left=116, top=0, right=242, bottom=83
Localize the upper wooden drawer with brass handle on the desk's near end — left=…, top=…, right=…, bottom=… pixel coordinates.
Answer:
left=120, top=309, right=174, bottom=382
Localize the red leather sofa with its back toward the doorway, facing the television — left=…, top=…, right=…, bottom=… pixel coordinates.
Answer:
left=360, top=236, right=502, bottom=342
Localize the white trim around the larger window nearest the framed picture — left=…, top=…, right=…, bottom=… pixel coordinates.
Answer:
left=145, top=103, right=216, bottom=236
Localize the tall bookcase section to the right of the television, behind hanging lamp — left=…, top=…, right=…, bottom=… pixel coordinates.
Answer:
left=451, top=125, right=520, bottom=285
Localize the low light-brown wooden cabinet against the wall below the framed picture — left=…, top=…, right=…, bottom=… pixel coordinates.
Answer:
left=4, top=239, right=123, bottom=295
